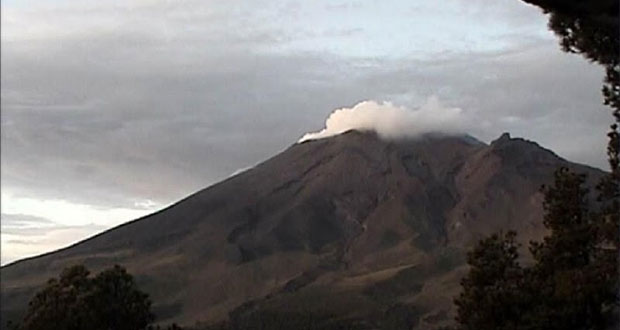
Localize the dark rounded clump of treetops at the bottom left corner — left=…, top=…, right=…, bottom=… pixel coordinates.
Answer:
left=16, top=265, right=155, bottom=330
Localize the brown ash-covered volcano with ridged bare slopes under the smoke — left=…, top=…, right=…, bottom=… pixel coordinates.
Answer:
left=1, top=131, right=601, bottom=327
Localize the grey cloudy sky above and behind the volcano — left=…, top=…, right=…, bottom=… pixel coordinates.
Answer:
left=0, top=0, right=611, bottom=264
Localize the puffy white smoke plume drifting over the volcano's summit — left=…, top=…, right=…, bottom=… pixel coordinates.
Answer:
left=298, top=96, right=465, bottom=143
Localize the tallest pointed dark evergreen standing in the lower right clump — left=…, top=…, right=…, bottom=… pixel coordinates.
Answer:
left=528, top=168, right=611, bottom=329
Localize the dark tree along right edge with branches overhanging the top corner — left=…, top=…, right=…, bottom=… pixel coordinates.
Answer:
left=523, top=0, right=620, bottom=324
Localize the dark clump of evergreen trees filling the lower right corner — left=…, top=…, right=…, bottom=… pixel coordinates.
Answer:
left=455, top=168, right=618, bottom=330
